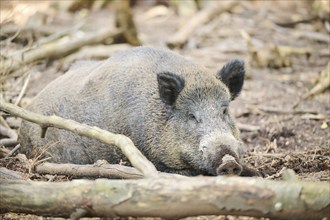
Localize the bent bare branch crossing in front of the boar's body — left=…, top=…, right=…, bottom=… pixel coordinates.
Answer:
left=0, top=102, right=157, bottom=177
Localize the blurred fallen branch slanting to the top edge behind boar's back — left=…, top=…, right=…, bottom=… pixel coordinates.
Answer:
left=166, top=1, right=238, bottom=48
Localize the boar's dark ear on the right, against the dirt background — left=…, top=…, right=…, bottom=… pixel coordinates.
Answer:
left=217, top=59, right=245, bottom=100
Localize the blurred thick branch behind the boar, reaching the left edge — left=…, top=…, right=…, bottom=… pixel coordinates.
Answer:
left=0, top=28, right=121, bottom=75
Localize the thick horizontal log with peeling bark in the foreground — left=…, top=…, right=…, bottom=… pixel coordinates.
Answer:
left=0, top=176, right=330, bottom=219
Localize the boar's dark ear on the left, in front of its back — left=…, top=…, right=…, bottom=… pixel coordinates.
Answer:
left=157, top=72, right=184, bottom=105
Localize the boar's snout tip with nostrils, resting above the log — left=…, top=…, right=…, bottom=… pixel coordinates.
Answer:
left=217, top=154, right=243, bottom=175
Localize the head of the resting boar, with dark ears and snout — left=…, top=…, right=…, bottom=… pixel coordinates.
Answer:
left=157, top=60, right=245, bottom=175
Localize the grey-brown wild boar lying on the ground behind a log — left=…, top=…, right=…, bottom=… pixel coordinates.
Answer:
left=19, top=47, right=255, bottom=175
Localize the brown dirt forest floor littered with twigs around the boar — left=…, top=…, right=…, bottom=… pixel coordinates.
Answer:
left=0, top=0, right=330, bottom=219
